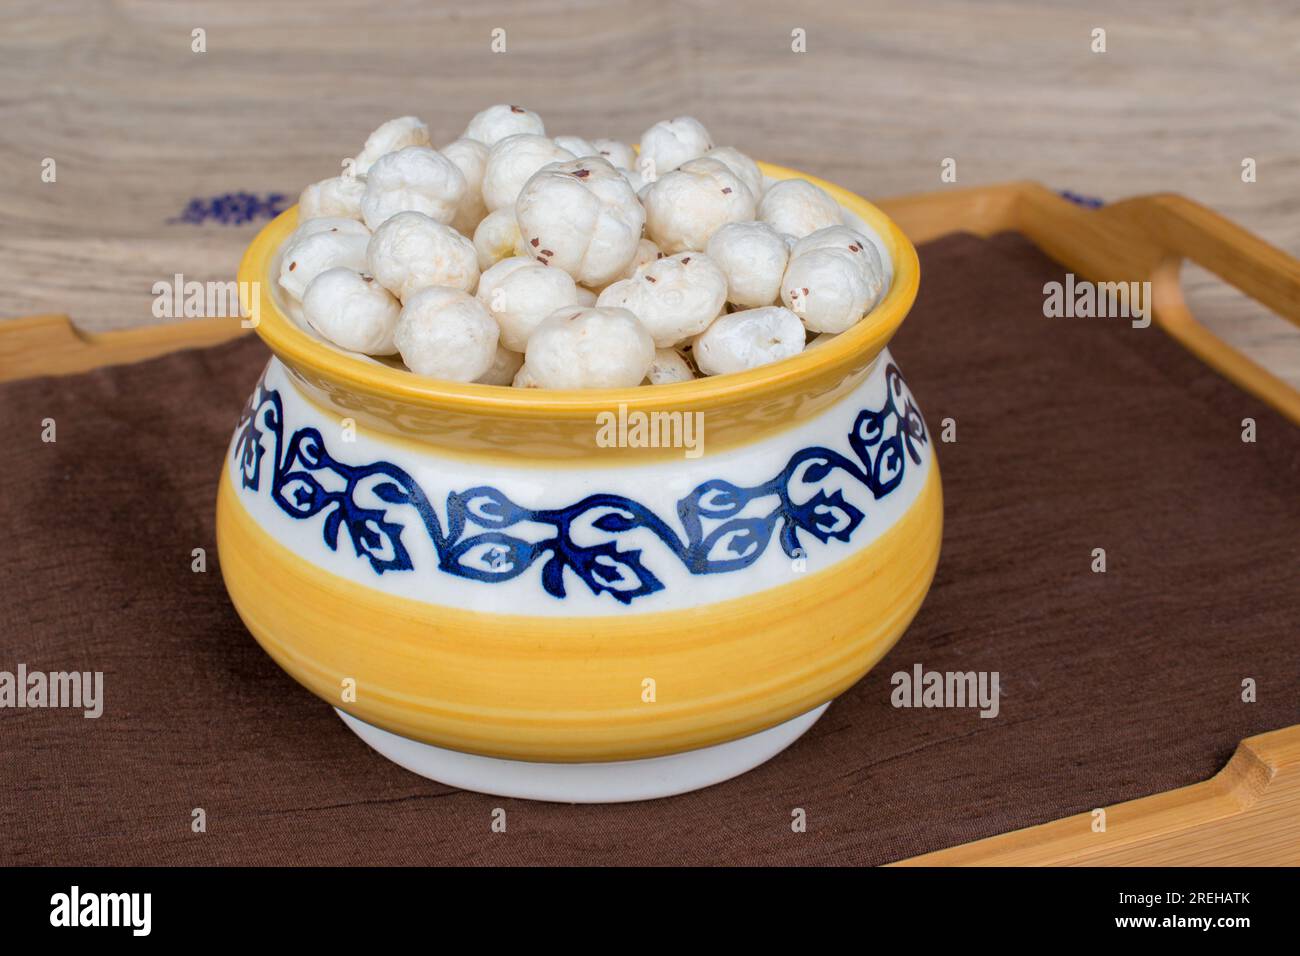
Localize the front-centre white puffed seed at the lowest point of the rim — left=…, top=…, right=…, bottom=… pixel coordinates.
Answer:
left=524, top=307, right=654, bottom=389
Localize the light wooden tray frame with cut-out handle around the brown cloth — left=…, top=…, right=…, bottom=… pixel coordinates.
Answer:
left=0, top=183, right=1300, bottom=865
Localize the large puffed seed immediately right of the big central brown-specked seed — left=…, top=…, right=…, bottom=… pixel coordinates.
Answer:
left=642, top=159, right=754, bottom=254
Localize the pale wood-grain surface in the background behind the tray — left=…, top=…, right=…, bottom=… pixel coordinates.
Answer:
left=0, top=0, right=1300, bottom=382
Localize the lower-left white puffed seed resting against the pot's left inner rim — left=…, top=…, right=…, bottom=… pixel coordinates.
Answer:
left=303, top=269, right=402, bottom=355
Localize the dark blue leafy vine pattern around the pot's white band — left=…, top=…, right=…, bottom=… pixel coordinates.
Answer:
left=234, top=364, right=928, bottom=604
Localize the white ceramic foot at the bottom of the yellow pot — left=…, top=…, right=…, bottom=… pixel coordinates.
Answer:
left=335, top=704, right=831, bottom=804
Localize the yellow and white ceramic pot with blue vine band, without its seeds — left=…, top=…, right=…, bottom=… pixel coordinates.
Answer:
left=217, top=166, right=943, bottom=803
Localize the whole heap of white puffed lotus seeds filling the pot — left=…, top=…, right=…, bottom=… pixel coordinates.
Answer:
left=280, top=104, right=887, bottom=388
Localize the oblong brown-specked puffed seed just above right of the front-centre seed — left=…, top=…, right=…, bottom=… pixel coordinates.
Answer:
left=595, top=252, right=727, bottom=349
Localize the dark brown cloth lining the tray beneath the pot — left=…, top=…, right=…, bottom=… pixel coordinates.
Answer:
left=0, top=235, right=1300, bottom=865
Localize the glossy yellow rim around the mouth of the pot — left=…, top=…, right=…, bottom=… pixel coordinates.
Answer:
left=238, top=163, right=920, bottom=418
